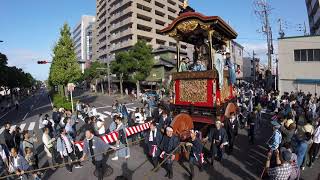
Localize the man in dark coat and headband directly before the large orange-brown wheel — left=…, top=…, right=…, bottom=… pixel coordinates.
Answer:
left=160, top=126, right=179, bottom=179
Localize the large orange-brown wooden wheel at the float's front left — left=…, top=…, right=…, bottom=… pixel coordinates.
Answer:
left=171, top=113, right=193, bottom=141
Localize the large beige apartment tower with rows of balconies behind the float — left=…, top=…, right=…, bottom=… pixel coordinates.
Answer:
left=94, top=0, right=187, bottom=61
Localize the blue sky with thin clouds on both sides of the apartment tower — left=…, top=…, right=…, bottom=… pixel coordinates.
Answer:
left=0, top=0, right=308, bottom=80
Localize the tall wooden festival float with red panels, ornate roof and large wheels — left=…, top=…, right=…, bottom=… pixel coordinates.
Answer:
left=161, top=1, right=237, bottom=141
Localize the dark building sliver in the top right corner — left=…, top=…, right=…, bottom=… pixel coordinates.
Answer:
left=306, top=0, right=320, bottom=35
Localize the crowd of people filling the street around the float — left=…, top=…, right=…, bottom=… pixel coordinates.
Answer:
left=0, top=85, right=320, bottom=179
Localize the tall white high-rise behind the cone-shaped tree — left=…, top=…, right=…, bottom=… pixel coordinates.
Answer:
left=72, top=15, right=96, bottom=72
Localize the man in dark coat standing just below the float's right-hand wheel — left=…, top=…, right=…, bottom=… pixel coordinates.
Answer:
left=224, top=112, right=239, bottom=154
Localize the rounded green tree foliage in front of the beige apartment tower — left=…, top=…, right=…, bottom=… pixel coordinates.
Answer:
left=111, top=40, right=154, bottom=82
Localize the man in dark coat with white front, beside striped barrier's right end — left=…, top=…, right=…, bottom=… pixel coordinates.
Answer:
left=145, top=121, right=163, bottom=168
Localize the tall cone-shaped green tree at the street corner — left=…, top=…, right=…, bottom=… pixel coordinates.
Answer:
left=49, top=23, right=81, bottom=96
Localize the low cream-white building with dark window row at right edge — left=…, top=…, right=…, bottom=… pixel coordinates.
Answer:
left=279, top=36, right=320, bottom=94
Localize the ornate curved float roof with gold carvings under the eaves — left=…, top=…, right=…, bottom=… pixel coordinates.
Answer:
left=160, top=10, right=238, bottom=40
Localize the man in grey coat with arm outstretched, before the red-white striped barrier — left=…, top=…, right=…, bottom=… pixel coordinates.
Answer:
left=80, top=129, right=115, bottom=180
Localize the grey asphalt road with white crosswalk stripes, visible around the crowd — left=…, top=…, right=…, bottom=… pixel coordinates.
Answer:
left=0, top=90, right=320, bottom=180
